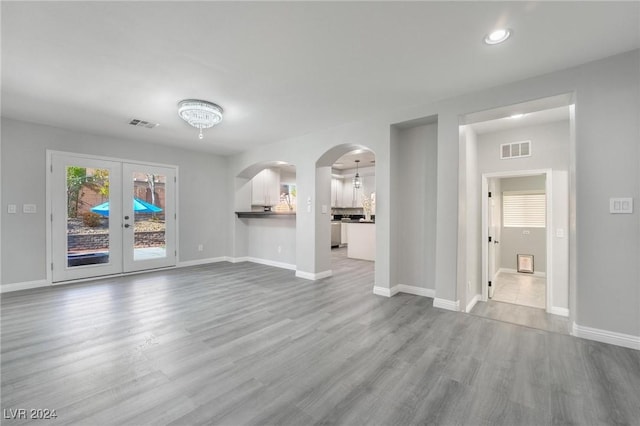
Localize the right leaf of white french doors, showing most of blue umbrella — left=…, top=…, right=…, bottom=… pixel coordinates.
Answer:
left=122, top=163, right=176, bottom=272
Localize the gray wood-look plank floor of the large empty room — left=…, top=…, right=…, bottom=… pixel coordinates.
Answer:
left=1, top=249, right=640, bottom=425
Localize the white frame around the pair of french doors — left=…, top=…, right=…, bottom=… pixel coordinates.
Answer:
left=45, top=149, right=180, bottom=285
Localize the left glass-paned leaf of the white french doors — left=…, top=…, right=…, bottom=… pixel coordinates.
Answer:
left=50, top=154, right=122, bottom=282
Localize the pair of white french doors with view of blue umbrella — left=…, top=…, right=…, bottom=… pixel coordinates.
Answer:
left=49, top=152, right=176, bottom=283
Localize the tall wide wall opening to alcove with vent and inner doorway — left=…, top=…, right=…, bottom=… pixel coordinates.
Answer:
left=458, top=94, right=575, bottom=333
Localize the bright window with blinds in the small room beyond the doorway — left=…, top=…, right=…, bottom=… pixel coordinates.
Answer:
left=502, top=191, right=547, bottom=228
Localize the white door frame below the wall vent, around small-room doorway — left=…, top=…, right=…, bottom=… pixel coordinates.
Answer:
left=480, top=169, right=554, bottom=313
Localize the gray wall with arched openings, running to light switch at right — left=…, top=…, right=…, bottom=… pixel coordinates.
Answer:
left=229, top=50, right=640, bottom=336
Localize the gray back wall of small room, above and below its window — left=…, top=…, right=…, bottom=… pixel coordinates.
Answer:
left=498, top=175, right=544, bottom=272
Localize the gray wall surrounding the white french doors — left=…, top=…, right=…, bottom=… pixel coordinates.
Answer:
left=1, top=118, right=229, bottom=284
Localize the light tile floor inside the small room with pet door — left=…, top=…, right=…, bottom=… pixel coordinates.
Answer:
left=492, top=272, right=546, bottom=309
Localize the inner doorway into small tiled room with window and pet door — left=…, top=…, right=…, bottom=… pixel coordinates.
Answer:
left=482, top=171, right=552, bottom=310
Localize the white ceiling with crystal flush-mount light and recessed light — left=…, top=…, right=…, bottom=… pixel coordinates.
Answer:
left=1, top=1, right=640, bottom=154
